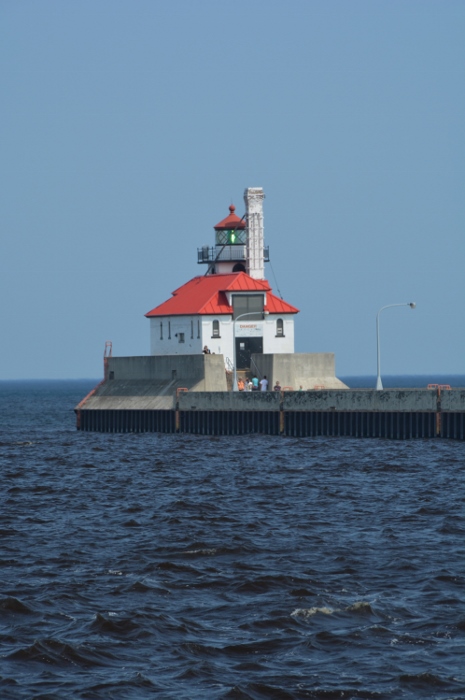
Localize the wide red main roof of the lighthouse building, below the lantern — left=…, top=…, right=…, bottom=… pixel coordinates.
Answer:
left=145, top=272, right=299, bottom=318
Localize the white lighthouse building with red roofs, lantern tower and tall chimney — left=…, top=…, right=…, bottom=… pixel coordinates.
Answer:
left=146, top=188, right=298, bottom=370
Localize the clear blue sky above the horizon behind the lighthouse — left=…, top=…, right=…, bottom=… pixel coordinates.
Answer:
left=0, top=0, right=465, bottom=379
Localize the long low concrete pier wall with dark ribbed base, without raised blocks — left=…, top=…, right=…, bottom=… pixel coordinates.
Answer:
left=76, top=385, right=465, bottom=440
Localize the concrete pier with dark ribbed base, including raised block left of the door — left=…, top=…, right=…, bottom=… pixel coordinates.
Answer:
left=75, top=355, right=465, bottom=440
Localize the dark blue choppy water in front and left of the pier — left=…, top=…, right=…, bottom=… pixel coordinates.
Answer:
left=0, top=382, right=465, bottom=700
